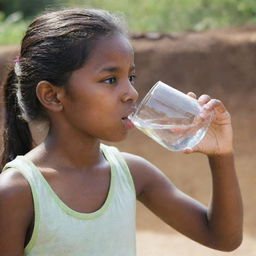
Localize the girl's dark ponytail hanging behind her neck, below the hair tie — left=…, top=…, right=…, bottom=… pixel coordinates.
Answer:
left=1, top=69, right=32, bottom=167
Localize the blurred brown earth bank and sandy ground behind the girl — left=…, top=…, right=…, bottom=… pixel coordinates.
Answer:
left=0, top=27, right=256, bottom=256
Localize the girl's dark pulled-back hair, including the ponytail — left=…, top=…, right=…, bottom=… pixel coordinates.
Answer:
left=2, top=9, right=126, bottom=168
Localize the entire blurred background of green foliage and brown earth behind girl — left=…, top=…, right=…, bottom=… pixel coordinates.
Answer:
left=0, top=0, right=256, bottom=256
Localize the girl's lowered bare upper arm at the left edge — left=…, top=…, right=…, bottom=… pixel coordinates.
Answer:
left=0, top=169, right=33, bottom=256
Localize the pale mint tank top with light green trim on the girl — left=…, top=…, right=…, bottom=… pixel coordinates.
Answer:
left=4, top=144, right=136, bottom=256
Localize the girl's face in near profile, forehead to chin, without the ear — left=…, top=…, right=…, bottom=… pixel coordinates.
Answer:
left=60, top=35, right=138, bottom=141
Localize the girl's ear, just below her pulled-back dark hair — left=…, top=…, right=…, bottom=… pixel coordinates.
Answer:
left=36, top=81, right=65, bottom=112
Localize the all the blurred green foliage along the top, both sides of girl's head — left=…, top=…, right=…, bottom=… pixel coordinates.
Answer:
left=0, top=0, right=256, bottom=44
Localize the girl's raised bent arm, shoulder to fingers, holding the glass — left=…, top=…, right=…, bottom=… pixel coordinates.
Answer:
left=125, top=95, right=243, bottom=251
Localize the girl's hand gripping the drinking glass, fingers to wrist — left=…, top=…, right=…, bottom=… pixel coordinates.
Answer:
left=183, top=93, right=233, bottom=155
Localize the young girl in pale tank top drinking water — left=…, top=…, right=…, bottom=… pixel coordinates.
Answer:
left=0, top=9, right=242, bottom=256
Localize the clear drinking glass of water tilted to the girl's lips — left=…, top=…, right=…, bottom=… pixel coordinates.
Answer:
left=129, top=81, right=213, bottom=151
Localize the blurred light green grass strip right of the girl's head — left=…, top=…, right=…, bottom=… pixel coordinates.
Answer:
left=60, top=0, right=256, bottom=31
